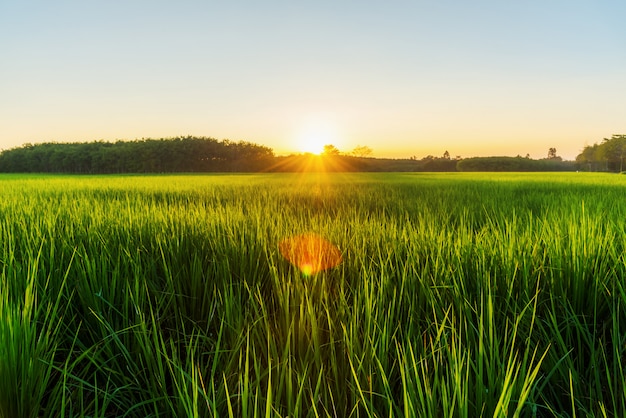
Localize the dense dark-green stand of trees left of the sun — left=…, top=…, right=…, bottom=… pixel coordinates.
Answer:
left=0, top=136, right=274, bottom=174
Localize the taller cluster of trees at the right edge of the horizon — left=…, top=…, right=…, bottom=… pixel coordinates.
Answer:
left=576, top=134, right=626, bottom=173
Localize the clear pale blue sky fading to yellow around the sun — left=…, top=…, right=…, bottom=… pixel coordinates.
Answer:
left=0, top=0, right=626, bottom=159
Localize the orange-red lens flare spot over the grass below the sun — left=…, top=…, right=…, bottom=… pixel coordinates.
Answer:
left=278, top=234, right=341, bottom=276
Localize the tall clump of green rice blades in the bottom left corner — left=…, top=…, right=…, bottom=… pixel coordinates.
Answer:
left=0, top=240, right=71, bottom=417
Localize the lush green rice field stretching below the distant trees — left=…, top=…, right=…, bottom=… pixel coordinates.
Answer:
left=0, top=173, right=626, bottom=418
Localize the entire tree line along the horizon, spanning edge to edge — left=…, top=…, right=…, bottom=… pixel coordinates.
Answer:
left=0, top=135, right=626, bottom=174
